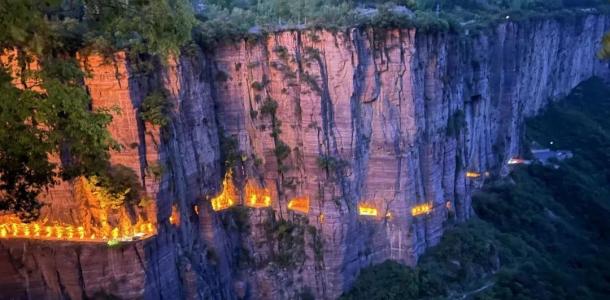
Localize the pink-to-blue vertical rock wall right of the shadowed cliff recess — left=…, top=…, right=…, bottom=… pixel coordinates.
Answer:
left=205, top=16, right=608, bottom=299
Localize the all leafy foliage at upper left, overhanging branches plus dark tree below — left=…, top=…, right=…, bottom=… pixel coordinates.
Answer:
left=0, top=0, right=194, bottom=221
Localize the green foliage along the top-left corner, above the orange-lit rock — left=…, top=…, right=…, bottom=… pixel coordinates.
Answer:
left=0, top=0, right=195, bottom=57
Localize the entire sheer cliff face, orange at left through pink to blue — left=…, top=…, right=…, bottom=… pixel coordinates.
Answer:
left=0, top=12, right=610, bottom=299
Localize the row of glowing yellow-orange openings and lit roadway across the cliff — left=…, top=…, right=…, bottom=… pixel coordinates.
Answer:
left=0, top=172, right=488, bottom=246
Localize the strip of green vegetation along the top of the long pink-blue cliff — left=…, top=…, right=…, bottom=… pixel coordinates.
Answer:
left=195, top=0, right=606, bottom=47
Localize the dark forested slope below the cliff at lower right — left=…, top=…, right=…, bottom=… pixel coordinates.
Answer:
left=343, top=79, right=610, bottom=300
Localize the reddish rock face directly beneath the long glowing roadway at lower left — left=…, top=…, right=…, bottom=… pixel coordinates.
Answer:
left=0, top=241, right=147, bottom=299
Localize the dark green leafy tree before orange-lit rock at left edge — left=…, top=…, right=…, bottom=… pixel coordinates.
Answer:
left=0, top=62, right=118, bottom=220
